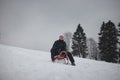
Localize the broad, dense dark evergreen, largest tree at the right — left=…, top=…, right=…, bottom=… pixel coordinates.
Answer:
left=99, top=21, right=118, bottom=63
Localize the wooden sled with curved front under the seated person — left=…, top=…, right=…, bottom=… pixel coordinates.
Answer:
left=54, top=51, right=69, bottom=64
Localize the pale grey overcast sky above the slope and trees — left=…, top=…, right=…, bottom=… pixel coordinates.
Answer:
left=0, top=0, right=120, bottom=51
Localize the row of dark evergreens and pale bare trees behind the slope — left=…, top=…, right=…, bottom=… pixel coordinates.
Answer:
left=64, top=20, right=120, bottom=63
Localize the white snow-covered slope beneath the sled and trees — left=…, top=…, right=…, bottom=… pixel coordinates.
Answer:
left=0, top=45, right=120, bottom=80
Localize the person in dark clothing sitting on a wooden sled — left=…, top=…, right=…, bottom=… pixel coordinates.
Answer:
left=50, top=35, right=75, bottom=65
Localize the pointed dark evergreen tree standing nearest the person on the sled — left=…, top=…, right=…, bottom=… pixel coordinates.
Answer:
left=72, top=24, right=87, bottom=58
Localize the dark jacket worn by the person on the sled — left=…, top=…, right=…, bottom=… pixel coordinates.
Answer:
left=51, top=40, right=66, bottom=54
